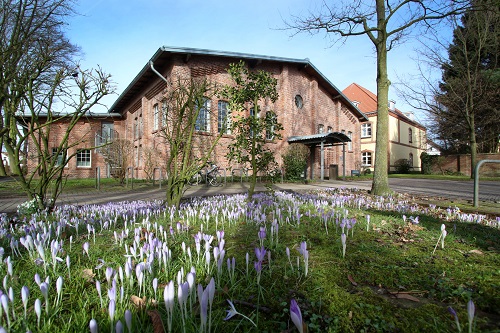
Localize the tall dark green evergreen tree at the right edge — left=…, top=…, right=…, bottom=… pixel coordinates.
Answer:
left=435, top=0, right=500, bottom=163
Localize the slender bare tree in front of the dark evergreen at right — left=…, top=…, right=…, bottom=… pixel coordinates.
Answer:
left=396, top=0, right=500, bottom=177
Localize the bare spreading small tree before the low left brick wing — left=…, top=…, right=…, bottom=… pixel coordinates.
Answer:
left=17, top=69, right=112, bottom=210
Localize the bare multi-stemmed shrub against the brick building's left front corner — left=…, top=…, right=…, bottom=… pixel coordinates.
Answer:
left=153, top=77, right=222, bottom=206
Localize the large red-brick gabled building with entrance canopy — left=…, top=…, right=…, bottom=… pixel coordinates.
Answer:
left=29, top=47, right=368, bottom=178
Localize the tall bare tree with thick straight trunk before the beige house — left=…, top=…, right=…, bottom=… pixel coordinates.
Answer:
left=287, top=0, right=469, bottom=195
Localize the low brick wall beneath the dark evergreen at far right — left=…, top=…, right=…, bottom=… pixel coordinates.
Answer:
left=432, top=154, right=500, bottom=177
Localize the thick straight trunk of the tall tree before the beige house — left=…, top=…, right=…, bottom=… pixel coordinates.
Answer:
left=371, top=0, right=391, bottom=195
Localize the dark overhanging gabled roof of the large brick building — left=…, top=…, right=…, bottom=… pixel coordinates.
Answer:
left=109, top=46, right=368, bottom=121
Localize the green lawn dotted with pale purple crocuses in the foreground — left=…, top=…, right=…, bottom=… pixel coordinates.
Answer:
left=0, top=189, right=500, bottom=332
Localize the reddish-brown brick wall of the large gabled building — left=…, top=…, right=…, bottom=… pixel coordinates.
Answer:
left=28, top=55, right=361, bottom=178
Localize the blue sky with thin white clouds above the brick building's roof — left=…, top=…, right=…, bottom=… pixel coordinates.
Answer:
left=68, top=0, right=446, bottom=122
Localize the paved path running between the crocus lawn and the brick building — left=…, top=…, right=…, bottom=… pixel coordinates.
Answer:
left=0, top=178, right=500, bottom=213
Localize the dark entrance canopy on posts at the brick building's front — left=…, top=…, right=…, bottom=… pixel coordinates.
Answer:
left=288, top=132, right=351, bottom=180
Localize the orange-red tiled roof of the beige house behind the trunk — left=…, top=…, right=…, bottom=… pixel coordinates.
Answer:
left=342, top=83, right=425, bottom=129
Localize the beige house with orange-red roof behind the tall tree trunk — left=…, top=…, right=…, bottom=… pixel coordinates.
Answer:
left=343, top=83, right=427, bottom=171
